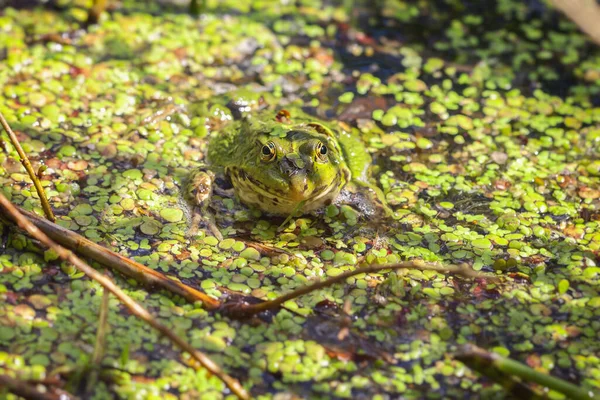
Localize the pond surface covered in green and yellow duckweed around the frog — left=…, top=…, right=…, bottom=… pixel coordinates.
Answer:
left=0, top=0, right=600, bottom=399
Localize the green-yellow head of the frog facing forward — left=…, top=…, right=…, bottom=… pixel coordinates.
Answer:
left=231, top=115, right=350, bottom=214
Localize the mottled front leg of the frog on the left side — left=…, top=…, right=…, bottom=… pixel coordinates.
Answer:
left=184, top=167, right=223, bottom=240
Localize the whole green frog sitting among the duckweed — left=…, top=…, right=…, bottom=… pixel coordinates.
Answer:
left=184, top=110, right=393, bottom=238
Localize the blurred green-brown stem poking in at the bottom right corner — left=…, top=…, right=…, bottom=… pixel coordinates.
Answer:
left=455, top=344, right=597, bottom=400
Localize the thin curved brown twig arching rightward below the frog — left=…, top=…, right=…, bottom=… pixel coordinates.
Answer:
left=227, top=261, right=498, bottom=316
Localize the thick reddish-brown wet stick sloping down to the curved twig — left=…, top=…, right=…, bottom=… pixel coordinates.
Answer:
left=6, top=207, right=220, bottom=310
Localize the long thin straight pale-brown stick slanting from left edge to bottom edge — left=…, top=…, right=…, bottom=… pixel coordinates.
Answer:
left=0, top=193, right=250, bottom=399
